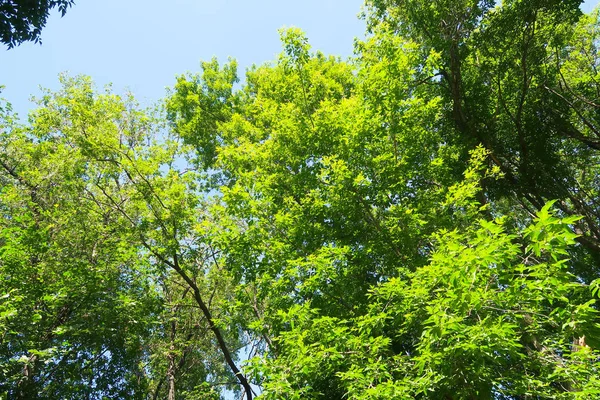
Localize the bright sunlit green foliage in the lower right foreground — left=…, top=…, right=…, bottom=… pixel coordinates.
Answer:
left=247, top=160, right=600, bottom=399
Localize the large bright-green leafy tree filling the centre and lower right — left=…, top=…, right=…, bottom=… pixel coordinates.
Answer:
left=168, top=25, right=598, bottom=399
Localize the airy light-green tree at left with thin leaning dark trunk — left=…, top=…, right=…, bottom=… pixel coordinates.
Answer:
left=0, top=77, right=241, bottom=399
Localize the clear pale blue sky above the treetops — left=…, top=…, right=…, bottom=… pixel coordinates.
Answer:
left=0, top=0, right=598, bottom=117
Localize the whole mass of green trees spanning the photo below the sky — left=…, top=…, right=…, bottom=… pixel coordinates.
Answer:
left=0, top=0, right=600, bottom=400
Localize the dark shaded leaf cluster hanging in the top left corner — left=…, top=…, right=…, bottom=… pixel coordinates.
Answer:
left=0, top=0, right=75, bottom=49
